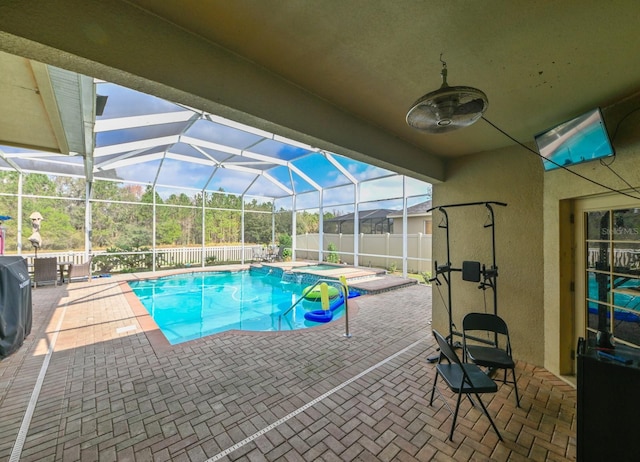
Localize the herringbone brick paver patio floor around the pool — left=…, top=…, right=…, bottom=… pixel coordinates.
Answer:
left=0, top=268, right=576, bottom=461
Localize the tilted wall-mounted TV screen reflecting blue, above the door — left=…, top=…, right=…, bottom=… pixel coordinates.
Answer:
left=535, top=108, right=615, bottom=171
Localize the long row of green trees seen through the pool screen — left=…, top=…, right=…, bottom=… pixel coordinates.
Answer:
left=0, top=171, right=319, bottom=256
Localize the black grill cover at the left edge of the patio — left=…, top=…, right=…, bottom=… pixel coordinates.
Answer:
left=0, top=256, right=32, bottom=357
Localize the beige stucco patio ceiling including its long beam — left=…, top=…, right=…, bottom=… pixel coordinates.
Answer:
left=0, top=0, right=640, bottom=181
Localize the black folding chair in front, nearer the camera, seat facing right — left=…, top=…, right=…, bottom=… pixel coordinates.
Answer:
left=429, top=330, right=502, bottom=441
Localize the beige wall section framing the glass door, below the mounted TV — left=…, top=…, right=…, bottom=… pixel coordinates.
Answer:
left=543, top=100, right=640, bottom=374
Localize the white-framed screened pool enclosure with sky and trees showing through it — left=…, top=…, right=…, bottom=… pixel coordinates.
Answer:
left=0, top=62, right=431, bottom=274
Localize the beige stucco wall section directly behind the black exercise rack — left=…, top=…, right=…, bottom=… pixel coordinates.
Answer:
left=432, top=143, right=544, bottom=365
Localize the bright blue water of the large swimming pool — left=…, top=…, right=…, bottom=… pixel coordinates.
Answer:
left=129, top=271, right=344, bottom=345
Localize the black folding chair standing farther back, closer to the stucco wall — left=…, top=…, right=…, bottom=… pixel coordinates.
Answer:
left=462, top=313, right=520, bottom=407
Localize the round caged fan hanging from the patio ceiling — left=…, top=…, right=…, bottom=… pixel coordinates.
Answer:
left=407, top=55, right=489, bottom=133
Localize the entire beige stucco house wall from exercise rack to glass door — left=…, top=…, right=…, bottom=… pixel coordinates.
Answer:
left=433, top=95, right=640, bottom=375
